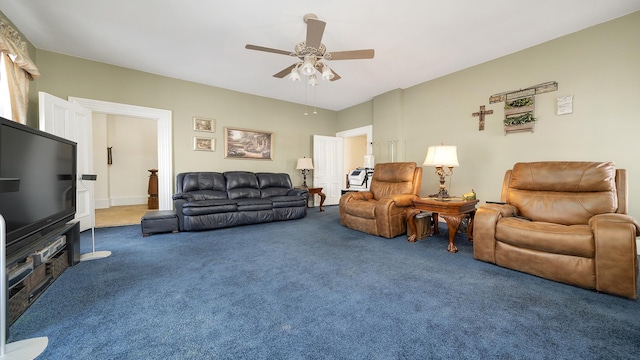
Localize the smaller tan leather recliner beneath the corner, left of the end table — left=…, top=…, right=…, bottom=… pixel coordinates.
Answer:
left=340, top=162, right=422, bottom=238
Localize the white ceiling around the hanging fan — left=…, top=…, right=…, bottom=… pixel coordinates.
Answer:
left=0, top=0, right=640, bottom=110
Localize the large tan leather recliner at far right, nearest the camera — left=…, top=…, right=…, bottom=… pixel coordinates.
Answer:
left=473, top=162, right=640, bottom=299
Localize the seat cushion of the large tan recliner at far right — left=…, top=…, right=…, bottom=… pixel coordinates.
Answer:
left=496, top=217, right=595, bottom=258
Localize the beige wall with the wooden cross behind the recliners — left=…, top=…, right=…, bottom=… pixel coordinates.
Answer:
left=339, top=12, right=640, bottom=219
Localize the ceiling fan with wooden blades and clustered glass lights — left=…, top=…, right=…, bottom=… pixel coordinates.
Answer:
left=245, top=14, right=374, bottom=86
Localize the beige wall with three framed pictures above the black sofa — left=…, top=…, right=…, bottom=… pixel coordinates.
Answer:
left=30, top=50, right=337, bottom=183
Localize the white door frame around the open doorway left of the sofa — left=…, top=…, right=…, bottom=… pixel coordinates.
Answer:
left=69, top=96, right=173, bottom=210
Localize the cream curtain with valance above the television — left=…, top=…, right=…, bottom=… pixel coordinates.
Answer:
left=0, top=19, right=40, bottom=124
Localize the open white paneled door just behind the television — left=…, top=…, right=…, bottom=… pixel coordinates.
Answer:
left=38, top=92, right=95, bottom=231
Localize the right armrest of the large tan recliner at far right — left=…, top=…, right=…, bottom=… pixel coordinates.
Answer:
left=589, top=213, right=640, bottom=299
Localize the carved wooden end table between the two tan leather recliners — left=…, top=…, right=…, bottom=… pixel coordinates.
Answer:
left=407, top=198, right=480, bottom=253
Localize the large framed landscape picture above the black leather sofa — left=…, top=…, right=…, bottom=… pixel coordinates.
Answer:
left=224, top=127, right=273, bottom=160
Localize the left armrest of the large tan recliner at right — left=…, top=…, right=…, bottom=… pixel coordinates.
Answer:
left=473, top=204, right=517, bottom=264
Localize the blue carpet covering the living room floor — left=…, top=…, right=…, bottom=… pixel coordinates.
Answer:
left=9, top=206, right=640, bottom=359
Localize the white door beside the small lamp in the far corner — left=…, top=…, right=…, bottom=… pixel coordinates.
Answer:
left=313, top=135, right=346, bottom=205
